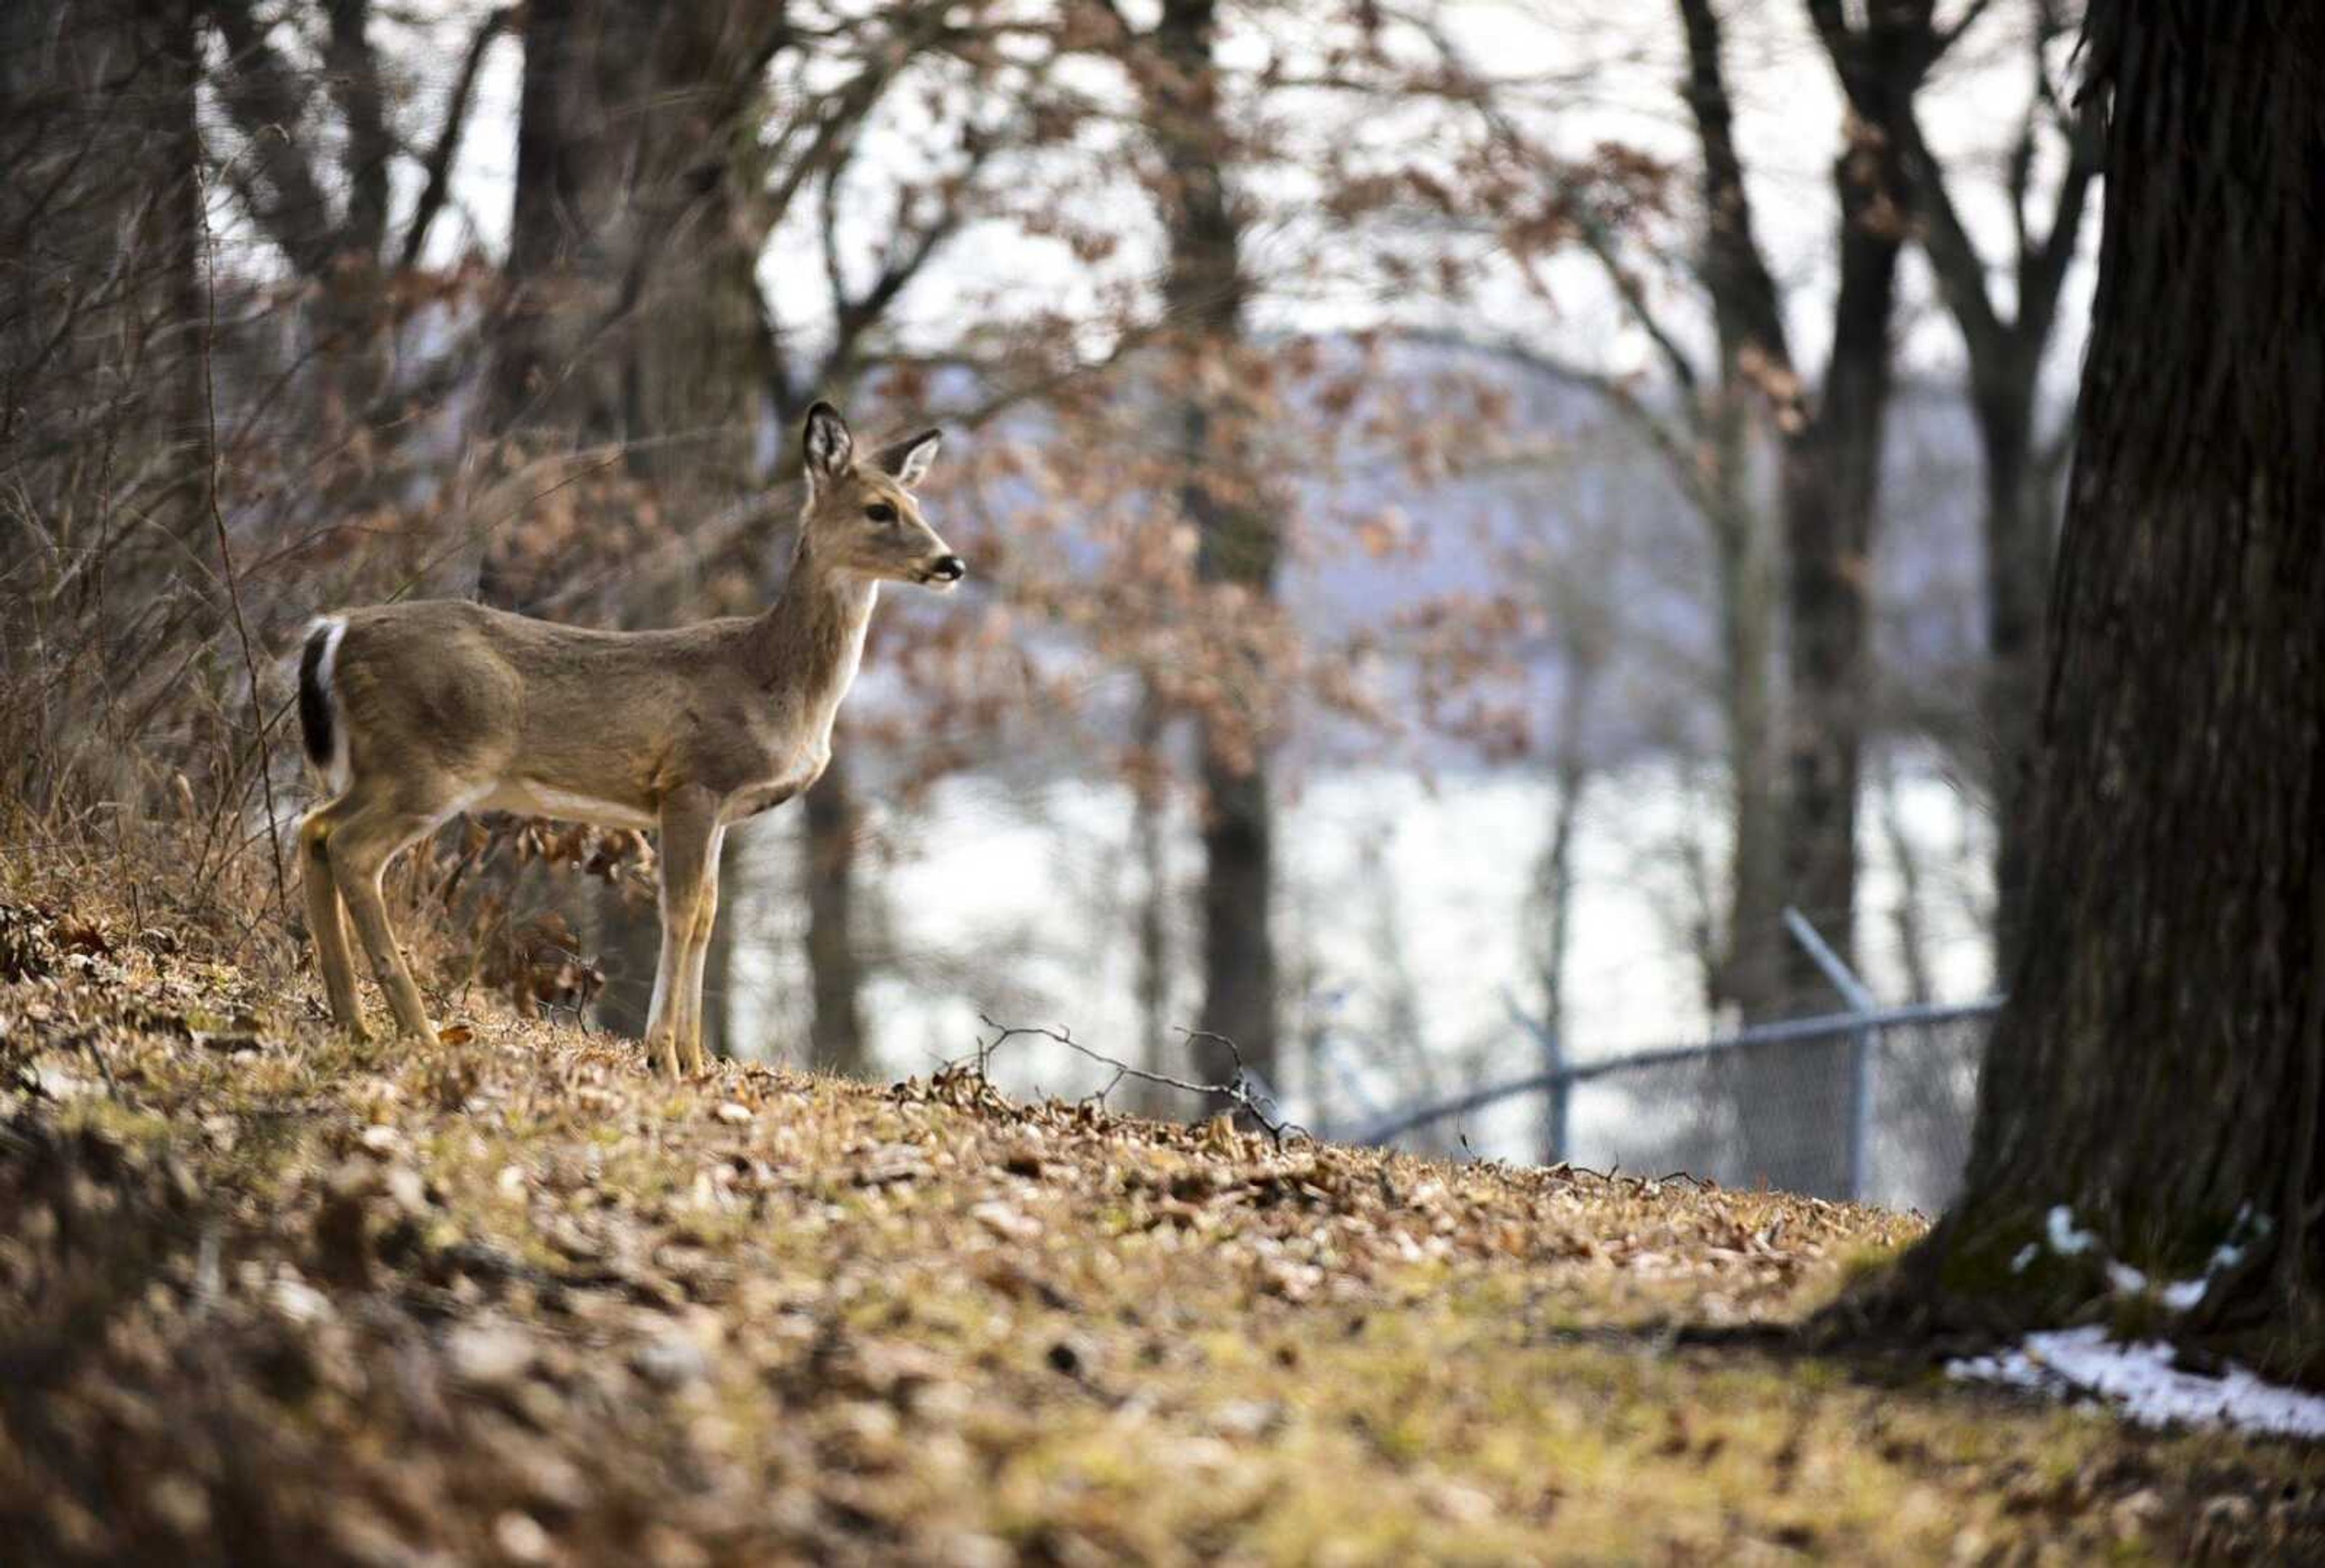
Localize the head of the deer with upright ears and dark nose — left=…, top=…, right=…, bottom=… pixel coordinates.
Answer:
left=800, top=403, right=969, bottom=593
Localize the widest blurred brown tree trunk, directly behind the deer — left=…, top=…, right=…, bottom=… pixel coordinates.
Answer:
left=479, top=0, right=783, bottom=1044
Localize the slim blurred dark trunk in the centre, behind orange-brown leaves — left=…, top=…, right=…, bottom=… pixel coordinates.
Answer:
left=1146, top=0, right=1279, bottom=1082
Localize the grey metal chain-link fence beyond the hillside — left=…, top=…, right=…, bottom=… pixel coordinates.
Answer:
left=1351, top=1000, right=1999, bottom=1212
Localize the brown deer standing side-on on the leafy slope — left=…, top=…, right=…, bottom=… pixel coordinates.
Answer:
left=298, top=403, right=967, bottom=1077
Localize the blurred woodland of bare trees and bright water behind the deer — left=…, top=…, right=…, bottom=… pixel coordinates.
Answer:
left=0, top=0, right=2097, bottom=1191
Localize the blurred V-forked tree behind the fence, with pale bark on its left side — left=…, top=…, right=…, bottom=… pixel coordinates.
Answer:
left=1525, top=0, right=1955, bottom=1191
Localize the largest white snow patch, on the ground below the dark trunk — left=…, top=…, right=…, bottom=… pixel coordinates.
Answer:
left=1946, top=1326, right=2325, bottom=1438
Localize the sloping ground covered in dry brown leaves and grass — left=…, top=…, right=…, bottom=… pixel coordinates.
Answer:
left=0, top=877, right=2325, bottom=1568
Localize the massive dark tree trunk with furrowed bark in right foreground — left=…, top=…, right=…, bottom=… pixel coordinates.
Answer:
left=1893, top=0, right=2325, bottom=1340
